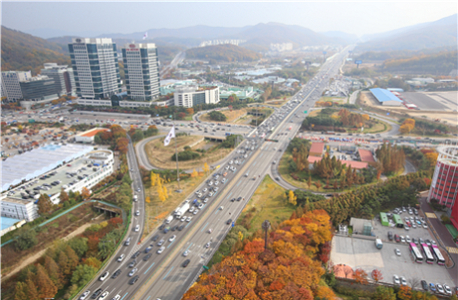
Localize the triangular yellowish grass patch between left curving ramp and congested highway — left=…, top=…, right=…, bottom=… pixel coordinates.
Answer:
left=142, top=173, right=205, bottom=238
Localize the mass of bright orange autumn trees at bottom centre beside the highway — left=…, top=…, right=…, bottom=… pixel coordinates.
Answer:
left=183, top=210, right=335, bottom=300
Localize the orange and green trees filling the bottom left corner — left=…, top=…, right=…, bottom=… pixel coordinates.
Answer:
left=11, top=218, right=123, bottom=300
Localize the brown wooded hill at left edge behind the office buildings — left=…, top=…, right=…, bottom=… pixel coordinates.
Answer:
left=2, top=26, right=70, bottom=75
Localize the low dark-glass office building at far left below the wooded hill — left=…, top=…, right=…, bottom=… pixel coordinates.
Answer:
left=19, top=75, right=59, bottom=104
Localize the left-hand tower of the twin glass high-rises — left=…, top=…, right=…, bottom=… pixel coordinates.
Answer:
left=68, top=38, right=121, bottom=99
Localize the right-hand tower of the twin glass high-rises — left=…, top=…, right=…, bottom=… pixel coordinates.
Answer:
left=122, top=43, right=160, bottom=101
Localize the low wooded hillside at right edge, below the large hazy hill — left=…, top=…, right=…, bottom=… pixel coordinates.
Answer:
left=383, top=51, right=458, bottom=75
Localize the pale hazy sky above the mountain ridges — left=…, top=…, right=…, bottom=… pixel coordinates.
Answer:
left=1, top=0, right=458, bottom=35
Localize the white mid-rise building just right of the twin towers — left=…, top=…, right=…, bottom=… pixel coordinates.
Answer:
left=174, top=85, right=219, bottom=107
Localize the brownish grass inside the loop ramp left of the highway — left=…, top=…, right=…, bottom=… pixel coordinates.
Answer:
left=145, top=135, right=231, bottom=169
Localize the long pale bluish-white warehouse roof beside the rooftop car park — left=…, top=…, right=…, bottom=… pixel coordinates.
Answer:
left=2, top=144, right=93, bottom=191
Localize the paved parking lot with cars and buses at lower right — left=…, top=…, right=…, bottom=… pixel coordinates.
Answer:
left=331, top=206, right=455, bottom=289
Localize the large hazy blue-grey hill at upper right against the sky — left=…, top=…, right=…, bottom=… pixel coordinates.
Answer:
left=355, top=14, right=458, bottom=51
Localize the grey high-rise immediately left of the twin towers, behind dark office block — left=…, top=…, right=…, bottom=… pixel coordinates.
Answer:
left=41, top=63, right=75, bottom=96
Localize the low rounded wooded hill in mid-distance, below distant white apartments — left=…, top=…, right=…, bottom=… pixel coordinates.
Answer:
left=186, top=45, right=261, bottom=62
